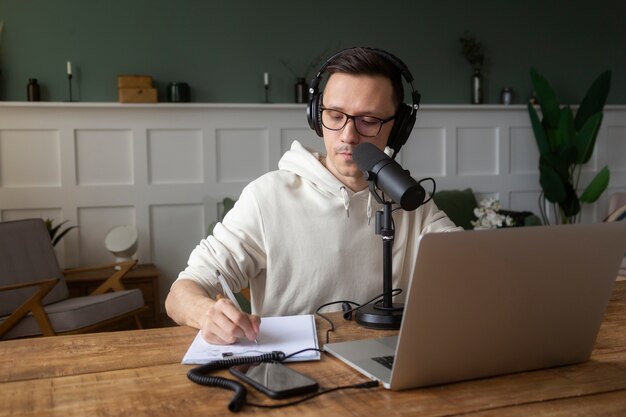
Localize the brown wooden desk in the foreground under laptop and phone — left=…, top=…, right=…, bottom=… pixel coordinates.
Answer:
left=0, top=281, right=626, bottom=417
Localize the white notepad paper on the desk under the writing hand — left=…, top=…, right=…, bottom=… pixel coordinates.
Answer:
left=182, top=314, right=320, bottom=364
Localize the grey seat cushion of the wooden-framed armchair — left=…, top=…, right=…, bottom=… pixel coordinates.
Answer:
left=0, top=289, right=144, bottom=339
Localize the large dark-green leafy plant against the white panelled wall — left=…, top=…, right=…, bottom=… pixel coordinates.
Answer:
left=528, top=69, right=611, bottom=224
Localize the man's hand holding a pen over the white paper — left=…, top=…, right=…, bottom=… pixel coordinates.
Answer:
left=200, top=298, right=261, bottom=345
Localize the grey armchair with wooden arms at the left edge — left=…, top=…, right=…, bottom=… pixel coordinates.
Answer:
left=0, top=219, right=146, bottom=339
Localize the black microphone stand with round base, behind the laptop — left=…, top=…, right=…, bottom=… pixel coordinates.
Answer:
left=355, top=179, right=404, bottom=329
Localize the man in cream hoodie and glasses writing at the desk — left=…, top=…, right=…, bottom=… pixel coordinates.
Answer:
left=165, top=48, right=458, bottom=344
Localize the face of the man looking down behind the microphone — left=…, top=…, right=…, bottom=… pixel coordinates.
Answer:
left=323, top=73, right=395, bottom=191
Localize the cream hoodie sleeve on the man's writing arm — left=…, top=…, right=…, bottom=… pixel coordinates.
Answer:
left=178, top=186, right=266, bottom=297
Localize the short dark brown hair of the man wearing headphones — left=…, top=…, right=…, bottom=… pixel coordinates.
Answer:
left=326, top=48, right=404, bottom=109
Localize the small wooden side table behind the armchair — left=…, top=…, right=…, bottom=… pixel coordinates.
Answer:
left=65, top=264, right=161, bottom=330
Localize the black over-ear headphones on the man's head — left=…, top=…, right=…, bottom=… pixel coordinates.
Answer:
left=306, top=48, right=421, bottom=158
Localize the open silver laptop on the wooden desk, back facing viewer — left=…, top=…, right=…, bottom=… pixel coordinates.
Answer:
left=324, top=222, right=626, bottom=390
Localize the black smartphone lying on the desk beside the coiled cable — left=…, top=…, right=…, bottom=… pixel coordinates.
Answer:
left=230, top=362, right=319, bottom=398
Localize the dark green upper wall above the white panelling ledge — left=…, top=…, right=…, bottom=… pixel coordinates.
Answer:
left=0, top=0, right=626, bottom=104
